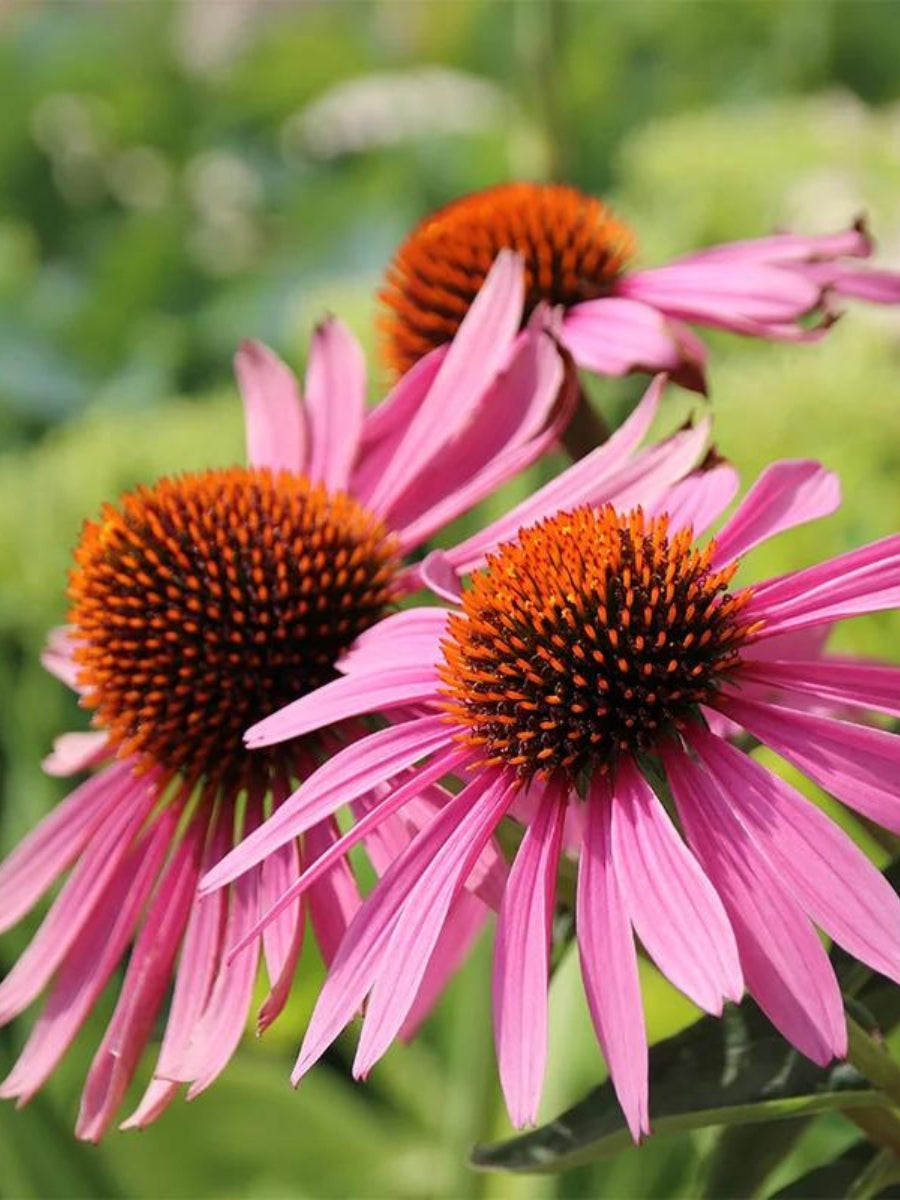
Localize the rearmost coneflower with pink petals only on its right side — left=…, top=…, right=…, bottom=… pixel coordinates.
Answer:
left=382, top=184, right=900, bottom=390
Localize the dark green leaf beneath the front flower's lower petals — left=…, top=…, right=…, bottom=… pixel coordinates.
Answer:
left=472, top=1002, right=888, bottom=1171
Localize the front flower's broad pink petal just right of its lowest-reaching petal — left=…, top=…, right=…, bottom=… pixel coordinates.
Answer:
left=611, top=761, right=744, bottom=1016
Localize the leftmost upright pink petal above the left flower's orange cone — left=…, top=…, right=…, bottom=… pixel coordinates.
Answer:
left=234, top=341, right=307, bottom=474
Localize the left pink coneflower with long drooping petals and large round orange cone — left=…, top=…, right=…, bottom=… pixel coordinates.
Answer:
left=0, top=254, right=592, bottom=1140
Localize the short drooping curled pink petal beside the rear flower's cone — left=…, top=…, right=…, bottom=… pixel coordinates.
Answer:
left=562, top=296, right=692, bottom=376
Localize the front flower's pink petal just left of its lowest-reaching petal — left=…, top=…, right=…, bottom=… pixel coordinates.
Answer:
left=493, top=790, right=566, bottom=1129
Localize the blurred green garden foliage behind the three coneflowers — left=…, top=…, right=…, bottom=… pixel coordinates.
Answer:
left=0, top=0, right=900, bottom=1198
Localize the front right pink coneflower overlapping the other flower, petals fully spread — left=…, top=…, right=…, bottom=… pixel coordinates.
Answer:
left=204, top=453, right=900, bottom=1138
